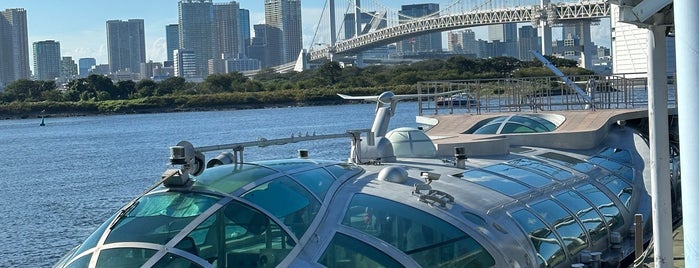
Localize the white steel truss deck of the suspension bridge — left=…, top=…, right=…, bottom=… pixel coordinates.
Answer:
left=309, top=0, right=610, bottom=61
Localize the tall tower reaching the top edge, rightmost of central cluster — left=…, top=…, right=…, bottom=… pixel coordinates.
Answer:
left=265, top=0, right=303, bottom=63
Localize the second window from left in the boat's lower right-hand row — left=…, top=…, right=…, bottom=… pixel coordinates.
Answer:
left=531, top=200, right=587, bottom=255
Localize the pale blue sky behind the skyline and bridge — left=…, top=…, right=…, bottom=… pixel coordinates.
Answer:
left=0, top=0, right=608, bottom=66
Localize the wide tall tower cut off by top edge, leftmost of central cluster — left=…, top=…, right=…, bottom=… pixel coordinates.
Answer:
left=178, top=0, right=218, bottom=78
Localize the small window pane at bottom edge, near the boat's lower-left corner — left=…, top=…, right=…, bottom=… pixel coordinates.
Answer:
left=97, top=248, right=156, bottom=267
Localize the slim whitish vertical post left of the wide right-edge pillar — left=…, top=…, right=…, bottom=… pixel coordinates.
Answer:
left=648, top=14, right=672, bottom=267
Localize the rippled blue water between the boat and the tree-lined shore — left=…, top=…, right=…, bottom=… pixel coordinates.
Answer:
left=0, top=102, right=417, bottom=267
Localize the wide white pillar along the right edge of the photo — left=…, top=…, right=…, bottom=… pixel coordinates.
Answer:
left=673, top=0, right=699, bottom=267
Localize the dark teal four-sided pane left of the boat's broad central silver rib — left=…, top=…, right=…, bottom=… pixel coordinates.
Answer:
left=242, top=177, right=320, bottom=238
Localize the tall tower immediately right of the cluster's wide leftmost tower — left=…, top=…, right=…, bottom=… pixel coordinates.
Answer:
left=209, top=2, right=241, bottom=59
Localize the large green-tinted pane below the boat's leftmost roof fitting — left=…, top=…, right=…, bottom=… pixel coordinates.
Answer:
left=105, top=192, right=218, bottom=245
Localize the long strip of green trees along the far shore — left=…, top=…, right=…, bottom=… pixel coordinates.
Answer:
left=0, top=56, right=592, bottom=117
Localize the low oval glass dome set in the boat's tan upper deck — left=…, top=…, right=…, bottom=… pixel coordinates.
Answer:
left=466, top=114, right=564, bottom=134
